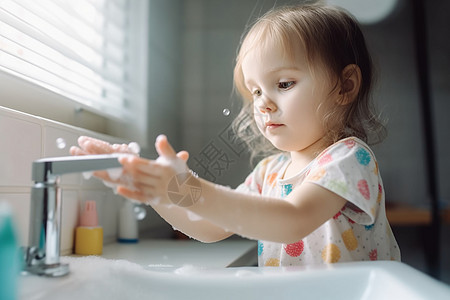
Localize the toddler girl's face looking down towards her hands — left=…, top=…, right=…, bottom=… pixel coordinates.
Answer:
left=242, top=42, right=336, bottom=151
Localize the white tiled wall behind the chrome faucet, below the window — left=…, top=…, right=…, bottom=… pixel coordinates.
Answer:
left=0, top=107, right=123, bottom=254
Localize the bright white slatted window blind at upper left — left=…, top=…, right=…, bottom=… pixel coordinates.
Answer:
left=0, top=0, right=139, bottom=119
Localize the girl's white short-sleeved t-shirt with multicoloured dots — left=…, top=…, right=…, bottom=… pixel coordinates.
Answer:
left=238, top=137, right=400, bottom=266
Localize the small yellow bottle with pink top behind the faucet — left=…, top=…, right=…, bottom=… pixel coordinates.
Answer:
left=75, top=201, right=103, bottom=255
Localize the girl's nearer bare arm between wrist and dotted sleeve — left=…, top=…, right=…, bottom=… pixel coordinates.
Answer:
left=190, top=180, right=346, bottom=244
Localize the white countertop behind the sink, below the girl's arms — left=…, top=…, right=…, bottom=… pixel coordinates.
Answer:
left=101, top=239, right=257, bottom=267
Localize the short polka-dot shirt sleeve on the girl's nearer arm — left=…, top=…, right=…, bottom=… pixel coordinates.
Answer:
left=305, top=139, right=382, bottom=225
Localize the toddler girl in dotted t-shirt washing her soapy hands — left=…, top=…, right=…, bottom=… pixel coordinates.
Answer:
left=71, top=5, right=400, bottom=266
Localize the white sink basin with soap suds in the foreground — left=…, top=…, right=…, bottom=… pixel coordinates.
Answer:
left=19, top=257, right=450, bottom=300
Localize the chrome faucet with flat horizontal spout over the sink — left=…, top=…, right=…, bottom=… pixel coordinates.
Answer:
left=24, top=154, right=122, bottom=277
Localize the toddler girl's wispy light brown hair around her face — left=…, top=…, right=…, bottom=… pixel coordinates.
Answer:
left=233, top=4, right=386, bottom=163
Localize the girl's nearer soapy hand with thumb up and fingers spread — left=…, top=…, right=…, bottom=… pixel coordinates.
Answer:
left=117, top=135, right=189, bottom=205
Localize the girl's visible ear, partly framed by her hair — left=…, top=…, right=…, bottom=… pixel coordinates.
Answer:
left=338, top=64, right=361, bottom=105
